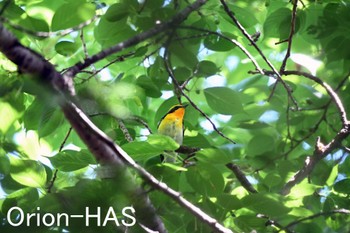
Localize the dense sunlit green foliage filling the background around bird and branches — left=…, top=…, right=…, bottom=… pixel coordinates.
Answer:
left=0, top=0, right=350, bottom=232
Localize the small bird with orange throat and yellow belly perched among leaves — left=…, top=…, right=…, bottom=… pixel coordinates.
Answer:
left=158, top=104, right=188, bottom=163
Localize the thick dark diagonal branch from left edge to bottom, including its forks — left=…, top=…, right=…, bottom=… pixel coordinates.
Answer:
left=0, top=0, right=232, bottom=233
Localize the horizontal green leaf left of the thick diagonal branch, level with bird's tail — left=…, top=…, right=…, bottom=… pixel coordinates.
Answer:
left=50, top=150, right=96, bottom=172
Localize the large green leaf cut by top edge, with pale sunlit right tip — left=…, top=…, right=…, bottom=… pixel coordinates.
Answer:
left=51, top=0, right=95, bottom=31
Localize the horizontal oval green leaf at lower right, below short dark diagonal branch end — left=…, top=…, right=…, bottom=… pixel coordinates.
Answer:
left=242, top=193, right=291, bottom=217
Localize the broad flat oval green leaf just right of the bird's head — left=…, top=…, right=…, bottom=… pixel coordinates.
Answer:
left=204, top=87, right=243, bottom=115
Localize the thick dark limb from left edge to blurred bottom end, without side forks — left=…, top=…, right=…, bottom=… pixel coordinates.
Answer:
left=0, top=19, right=166, bottom=233
